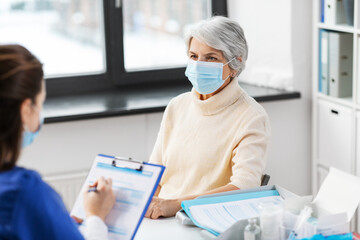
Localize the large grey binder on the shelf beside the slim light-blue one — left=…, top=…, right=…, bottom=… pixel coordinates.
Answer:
left=329, top=32, right=353, bottom=98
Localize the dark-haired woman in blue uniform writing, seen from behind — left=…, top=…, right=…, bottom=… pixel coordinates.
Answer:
left=0, top=45, right=115, bottom=240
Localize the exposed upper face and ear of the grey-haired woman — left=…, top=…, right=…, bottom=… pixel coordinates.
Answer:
left=188, top=38, right=236, bottom=81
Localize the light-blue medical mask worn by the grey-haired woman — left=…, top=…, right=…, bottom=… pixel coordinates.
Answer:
left=185, top=58, right=235, bottom=94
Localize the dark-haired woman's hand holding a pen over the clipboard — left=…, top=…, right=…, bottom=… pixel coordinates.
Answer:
left=84, top=177, right=115, bottom=221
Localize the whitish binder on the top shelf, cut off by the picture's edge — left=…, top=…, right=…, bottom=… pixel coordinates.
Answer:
left=324, top=0, right=347, bottom=25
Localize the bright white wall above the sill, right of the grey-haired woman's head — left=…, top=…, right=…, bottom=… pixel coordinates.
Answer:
left=228, top=0, right=294, bottom=90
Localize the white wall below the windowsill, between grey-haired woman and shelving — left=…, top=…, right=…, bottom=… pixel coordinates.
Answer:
left=262, top=99, right=311, bottom=195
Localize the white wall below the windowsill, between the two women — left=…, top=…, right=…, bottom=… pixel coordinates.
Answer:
left=19, top=113, right=162, bottom=176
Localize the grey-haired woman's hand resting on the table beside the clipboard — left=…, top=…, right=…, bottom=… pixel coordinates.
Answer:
left=145, top=197, right=181, bottom=219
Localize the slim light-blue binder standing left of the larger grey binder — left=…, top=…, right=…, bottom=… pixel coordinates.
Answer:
left=319, top=30, right=329, bottom=95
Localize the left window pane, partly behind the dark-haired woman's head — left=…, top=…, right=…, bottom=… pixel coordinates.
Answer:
left=0, top=0, right=106, bottom=77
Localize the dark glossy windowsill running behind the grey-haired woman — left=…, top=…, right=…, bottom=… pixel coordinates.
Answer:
left=44, top=81, right=300, bottom=123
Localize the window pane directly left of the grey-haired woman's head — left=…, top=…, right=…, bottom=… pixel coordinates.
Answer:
left=122, top=0, right=211, bottom=71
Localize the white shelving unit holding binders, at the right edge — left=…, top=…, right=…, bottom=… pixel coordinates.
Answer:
left=312, top=0, right=360, bottom=231
